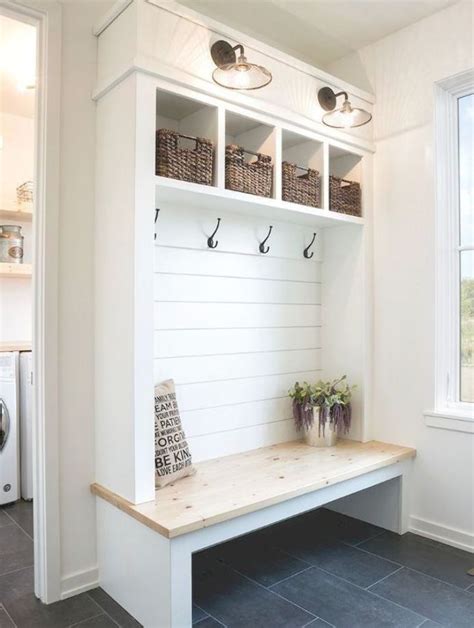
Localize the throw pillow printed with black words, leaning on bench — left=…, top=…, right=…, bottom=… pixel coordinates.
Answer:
left=155, top=379, right=196, bottom=488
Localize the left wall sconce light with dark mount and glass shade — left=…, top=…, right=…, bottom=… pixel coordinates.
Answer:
left=211, top=39, right=272, bottom=89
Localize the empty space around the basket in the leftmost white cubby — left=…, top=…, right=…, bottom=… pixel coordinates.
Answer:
left=156, top=90, right=218, bottom=185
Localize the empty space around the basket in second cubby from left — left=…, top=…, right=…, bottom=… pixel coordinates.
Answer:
left=225, top=111, right=276, bottom=198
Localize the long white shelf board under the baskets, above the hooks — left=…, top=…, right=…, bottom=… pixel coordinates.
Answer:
left=155, top=177, right=364, bottom=227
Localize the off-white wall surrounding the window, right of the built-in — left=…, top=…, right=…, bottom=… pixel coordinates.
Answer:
left=328, top=2, right=474, bottom=549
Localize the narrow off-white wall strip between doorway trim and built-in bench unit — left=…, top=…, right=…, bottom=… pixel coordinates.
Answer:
left=59, top=1, right=113, bottom=591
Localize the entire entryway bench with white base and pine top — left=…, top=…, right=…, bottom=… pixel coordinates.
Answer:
left=91, top=441, right=415, bottom=628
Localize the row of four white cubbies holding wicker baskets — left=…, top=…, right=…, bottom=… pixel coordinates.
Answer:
left=155, top=90, right=364, bottom=226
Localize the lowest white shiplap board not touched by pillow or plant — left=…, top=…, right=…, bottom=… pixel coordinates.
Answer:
left=154, top=327, right=321, bottom=358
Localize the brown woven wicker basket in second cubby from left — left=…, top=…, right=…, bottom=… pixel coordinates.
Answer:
left=225, top=144, right=273, bottom=196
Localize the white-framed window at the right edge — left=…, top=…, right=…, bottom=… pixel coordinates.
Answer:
left=425, top=70, right=474, bottom=432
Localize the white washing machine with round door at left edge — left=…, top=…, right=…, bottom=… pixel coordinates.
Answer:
left=0, top=352, right=20, bottom=505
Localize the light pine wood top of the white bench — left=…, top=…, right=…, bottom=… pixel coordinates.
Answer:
left=91, top=440, right=416, bottom=538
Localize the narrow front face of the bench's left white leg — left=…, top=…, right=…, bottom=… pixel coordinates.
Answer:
left=170, top=537, right=193, bottom=628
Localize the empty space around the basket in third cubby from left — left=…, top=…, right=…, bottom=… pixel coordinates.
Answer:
left=281, top=129, right=325, bottom=207
